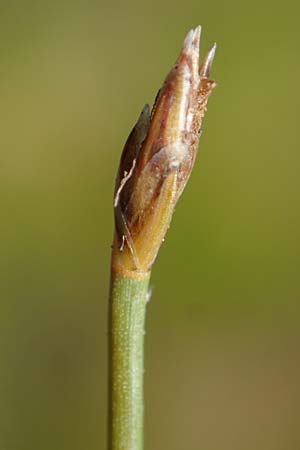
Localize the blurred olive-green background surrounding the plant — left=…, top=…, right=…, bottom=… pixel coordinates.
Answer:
left=0, top=0, right=300, bottom=450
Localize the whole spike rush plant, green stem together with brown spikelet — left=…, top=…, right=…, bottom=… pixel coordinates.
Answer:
left=108, top=26, right=216, bottom=450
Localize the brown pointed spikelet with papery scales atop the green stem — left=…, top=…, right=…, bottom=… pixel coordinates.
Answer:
left=113, top=27, right=216, bottom=276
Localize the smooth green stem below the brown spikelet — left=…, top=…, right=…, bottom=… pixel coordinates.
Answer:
left=108, top=274, right=150, bottom=450
